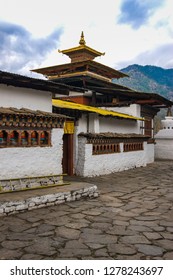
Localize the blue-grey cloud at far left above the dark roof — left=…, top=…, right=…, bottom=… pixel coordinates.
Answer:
left=0, top=22, right=61, bottom=74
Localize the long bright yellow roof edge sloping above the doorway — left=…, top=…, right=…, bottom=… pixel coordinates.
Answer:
left=52, top=99, right=144, bottom=121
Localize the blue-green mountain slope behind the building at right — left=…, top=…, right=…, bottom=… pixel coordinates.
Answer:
left=114, top=64, right=173, bottom=100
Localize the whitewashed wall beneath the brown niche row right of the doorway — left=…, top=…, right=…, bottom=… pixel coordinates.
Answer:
left=76, top=137, right=149, bottom=177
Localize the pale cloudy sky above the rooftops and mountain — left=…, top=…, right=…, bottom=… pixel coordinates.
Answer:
left=0, top=0, right=173, bottom=78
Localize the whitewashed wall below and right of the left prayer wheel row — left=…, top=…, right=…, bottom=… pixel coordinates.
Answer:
left=0, top=128, right=63, bottom=180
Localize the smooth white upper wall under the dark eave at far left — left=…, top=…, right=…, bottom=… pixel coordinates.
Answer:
left=0, top=85, right=52, bottom=112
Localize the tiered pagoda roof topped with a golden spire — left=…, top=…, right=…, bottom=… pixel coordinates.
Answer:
left=32, top=32, right=128, bottom=84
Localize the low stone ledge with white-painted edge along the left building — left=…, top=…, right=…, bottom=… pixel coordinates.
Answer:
left=0, top=182, right=99, bottom=216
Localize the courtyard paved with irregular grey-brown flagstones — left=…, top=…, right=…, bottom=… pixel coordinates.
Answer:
left=0, top=161, right=173, bottom=260
